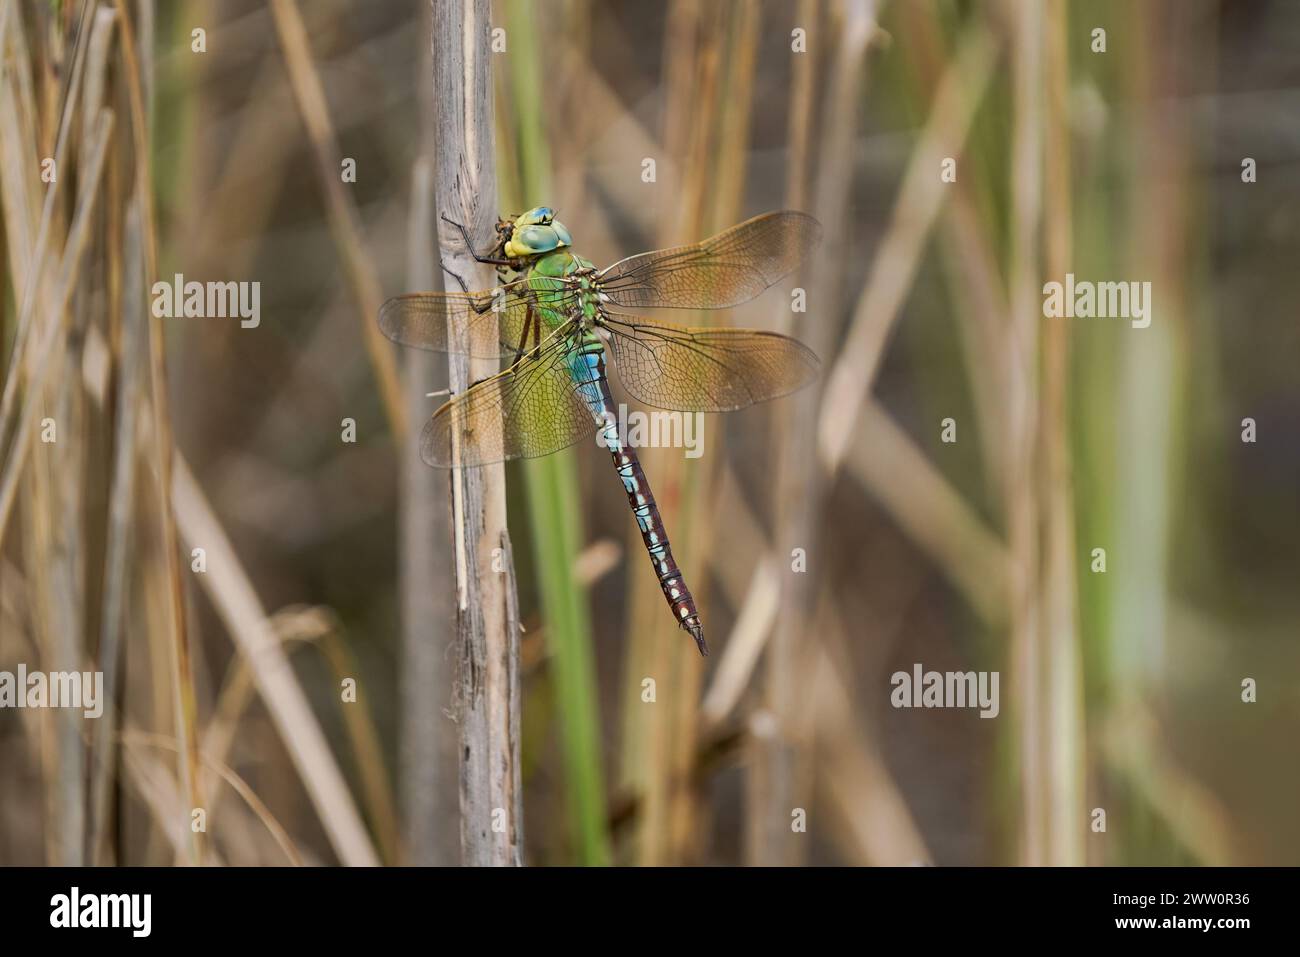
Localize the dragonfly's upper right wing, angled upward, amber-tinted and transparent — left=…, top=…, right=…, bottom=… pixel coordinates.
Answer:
left=598, top=209, right=822, bottom=309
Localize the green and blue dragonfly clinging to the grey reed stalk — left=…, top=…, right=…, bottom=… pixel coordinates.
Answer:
left=378, top=207, right=822, bottom=655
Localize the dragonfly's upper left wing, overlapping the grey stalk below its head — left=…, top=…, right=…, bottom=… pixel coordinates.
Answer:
left=380, top=280, right=576, bottom=359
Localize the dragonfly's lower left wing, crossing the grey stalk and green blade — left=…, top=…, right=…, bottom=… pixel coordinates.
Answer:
left=420, top=326, right=595, bottom=468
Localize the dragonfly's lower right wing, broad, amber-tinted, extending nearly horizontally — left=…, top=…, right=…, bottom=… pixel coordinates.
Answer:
left=605, top=315, right=822, bottom=412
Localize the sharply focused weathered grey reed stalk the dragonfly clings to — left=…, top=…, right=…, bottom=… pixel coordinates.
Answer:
left=430, top=0, right=524, bottom=865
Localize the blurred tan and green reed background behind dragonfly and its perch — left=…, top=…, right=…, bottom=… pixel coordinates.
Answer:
left=0, top=0, right=1300, bottom=865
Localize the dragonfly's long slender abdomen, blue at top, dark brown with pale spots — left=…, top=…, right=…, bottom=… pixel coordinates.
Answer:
left=569, top=335, right=709, bottom=655
